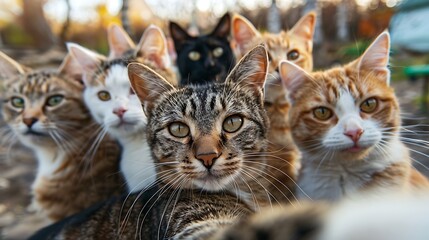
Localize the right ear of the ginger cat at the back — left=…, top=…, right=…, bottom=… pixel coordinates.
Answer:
left=290, top=11, right=316, bottom=52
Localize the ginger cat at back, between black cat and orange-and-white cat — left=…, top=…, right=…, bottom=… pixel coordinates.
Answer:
left=232, top=12, right=316, bottom=202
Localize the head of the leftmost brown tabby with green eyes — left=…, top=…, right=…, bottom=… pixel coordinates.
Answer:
left=0, top=54, right=91, bottom=150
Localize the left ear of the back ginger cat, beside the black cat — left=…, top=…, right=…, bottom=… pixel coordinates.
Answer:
left=232, top=14, right=261, bottom=54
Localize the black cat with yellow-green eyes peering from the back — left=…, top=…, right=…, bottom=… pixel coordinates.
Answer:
left=170, top=13, right=234, bottom=85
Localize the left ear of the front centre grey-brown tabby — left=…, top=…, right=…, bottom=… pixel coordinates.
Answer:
left=128, top=63, right=174, bottom=113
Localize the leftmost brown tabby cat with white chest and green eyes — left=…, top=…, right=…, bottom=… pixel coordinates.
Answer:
left=0, top=53, right=123, bottom=221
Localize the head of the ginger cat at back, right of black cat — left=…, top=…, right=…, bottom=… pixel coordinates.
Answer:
left=232, top=12, right=316, bottom=103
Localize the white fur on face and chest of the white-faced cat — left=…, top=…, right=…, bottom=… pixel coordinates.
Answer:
left=84, top=65, right=156, bottom=192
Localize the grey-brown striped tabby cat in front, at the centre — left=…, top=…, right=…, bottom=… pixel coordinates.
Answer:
left=33, top=46, right=268, bottom=239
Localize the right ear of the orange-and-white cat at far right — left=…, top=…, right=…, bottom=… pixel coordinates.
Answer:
left=357, top=32, right=390, bottom=84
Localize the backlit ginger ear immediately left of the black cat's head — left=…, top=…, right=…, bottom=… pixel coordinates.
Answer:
left=137, top=25, right=171, bottom=69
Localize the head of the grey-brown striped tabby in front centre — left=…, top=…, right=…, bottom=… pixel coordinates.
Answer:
left=128, top=46, right=268, bottom=191
